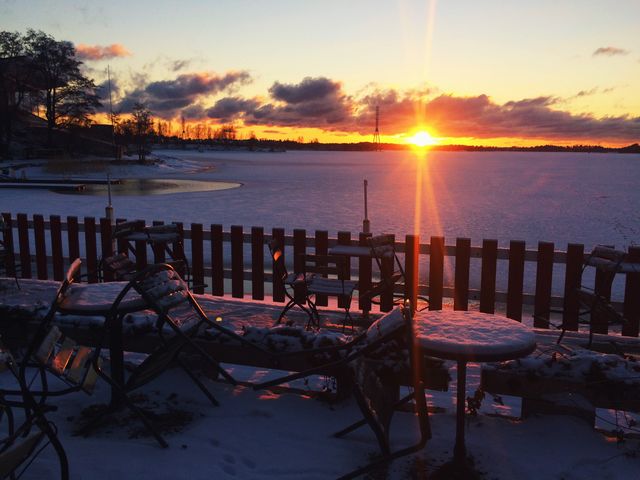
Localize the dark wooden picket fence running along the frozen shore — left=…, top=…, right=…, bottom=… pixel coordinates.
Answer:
left=2, top=213, right=640, bottom=336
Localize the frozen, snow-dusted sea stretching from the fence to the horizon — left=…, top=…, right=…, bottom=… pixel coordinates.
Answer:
left=0, top=150, right=640, bottom=250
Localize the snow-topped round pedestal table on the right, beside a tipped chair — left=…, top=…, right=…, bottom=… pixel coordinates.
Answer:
left=414, top=310, right=536, bottom=463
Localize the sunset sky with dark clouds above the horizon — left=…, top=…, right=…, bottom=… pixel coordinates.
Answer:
left=0, top=0, right=640, bottom=146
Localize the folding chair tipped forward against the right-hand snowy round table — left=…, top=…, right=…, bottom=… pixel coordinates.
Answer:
left=254, top=307, right=431, bottom=479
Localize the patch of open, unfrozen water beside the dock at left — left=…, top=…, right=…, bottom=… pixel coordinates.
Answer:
left=51, top=178, right=242, bottom=196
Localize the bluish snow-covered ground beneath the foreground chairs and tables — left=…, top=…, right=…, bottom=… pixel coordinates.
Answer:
left=0, top=284, right=640, bottom=480
